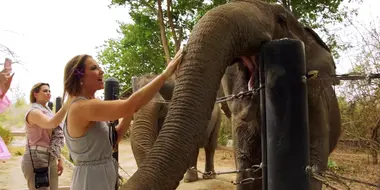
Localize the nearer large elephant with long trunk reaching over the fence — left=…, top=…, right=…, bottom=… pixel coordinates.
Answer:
left=122, top=0, right=341, bottom=190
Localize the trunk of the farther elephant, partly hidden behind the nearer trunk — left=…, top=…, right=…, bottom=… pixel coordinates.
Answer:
left=131, top=102, right=158, bottom=167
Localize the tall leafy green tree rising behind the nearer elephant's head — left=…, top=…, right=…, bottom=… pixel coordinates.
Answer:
left=98, top=0, right=360, bottom=92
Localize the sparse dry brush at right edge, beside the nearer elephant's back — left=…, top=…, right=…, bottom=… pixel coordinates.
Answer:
left=340, top=18, right=380, bottom=164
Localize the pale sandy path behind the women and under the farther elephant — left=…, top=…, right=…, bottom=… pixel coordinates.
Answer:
left=0, top=139, right=235, bottom=190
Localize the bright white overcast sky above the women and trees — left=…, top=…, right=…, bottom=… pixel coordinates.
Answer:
left=0, top=0, right=380, bottom=104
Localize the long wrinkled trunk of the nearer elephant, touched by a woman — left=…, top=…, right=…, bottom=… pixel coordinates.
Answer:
left=122, top=2, right=273, bottom=190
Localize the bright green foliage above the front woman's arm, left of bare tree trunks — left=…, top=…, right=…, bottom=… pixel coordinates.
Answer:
left=98, top=19, right=165, bottom=89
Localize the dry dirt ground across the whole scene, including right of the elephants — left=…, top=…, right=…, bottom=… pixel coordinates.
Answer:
left=0, top=138, right=380, bottom=190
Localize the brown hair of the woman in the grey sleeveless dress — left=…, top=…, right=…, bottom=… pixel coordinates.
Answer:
left=62, top=54, right=91, bottom=101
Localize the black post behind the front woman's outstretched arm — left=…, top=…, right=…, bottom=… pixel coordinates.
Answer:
left=104, top=77, right=119, bottom=161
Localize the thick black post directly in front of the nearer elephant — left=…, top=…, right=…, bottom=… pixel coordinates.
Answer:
left=262, top=39, right=310, bottom=190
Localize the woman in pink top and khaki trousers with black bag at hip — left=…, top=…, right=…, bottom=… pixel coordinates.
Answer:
left=21, top=83, right=69, bottom=190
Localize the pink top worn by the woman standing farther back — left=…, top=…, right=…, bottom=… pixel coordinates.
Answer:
left=25, top=104, right=51, bottom=148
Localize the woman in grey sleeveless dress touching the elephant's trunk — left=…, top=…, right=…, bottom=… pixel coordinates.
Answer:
left=64, top=51, right=181, bottom=190
